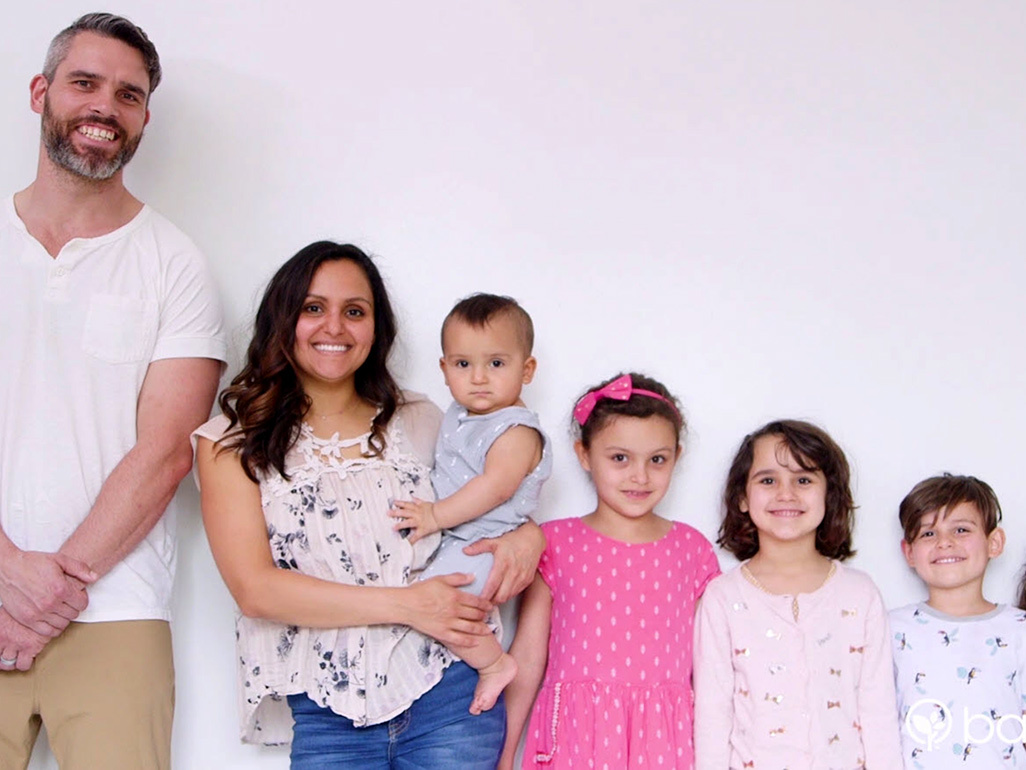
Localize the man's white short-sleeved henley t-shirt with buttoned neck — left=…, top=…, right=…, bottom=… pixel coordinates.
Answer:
left=0, top=196, right=227, bottom=622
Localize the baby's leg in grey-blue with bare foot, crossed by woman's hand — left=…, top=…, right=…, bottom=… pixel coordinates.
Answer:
left=421, top=537, right=516, bottom=714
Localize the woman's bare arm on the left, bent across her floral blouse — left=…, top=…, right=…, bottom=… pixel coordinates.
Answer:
left=196, top=438, right=491, bottom=645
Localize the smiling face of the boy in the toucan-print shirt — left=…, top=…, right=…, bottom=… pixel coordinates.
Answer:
left=901, top=502, right=1004, bottom=598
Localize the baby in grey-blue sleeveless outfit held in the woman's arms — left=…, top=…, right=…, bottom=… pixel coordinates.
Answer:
left=392, top=294, right=552, bottom=714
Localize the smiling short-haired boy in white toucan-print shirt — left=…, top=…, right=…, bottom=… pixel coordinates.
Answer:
left=891, top=474, right=1026, bottom=770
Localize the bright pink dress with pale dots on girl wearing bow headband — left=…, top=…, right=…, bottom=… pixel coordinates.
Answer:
left=523, top=518, right=719, bottom=770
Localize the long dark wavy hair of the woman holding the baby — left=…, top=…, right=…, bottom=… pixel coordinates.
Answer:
left=218, top=240, right=402, bottom=482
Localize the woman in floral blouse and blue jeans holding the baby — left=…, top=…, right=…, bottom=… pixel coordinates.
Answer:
left=196, top=241, right=544, bottom=769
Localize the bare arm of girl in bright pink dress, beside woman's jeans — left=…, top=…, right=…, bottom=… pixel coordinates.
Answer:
left=499, top=575, right=552, bottom=770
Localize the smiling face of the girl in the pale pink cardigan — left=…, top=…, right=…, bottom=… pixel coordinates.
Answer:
left=741, top=435, right=827, bottom=550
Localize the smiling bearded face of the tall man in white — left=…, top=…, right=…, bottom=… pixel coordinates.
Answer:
left=32, top=32, right=150, bottom=180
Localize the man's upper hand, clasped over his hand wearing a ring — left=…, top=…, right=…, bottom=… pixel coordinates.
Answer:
left=0, top=550, right=97, bottom=636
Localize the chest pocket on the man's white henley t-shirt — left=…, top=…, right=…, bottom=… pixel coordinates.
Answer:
left=82, top=294, right=158, bottom=363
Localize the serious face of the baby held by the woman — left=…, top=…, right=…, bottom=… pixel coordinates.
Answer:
left=439, top=314, right=537, bottom=415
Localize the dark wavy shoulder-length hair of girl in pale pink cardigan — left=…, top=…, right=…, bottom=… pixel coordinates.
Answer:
left=716, top=420, right=855, bottom=562
